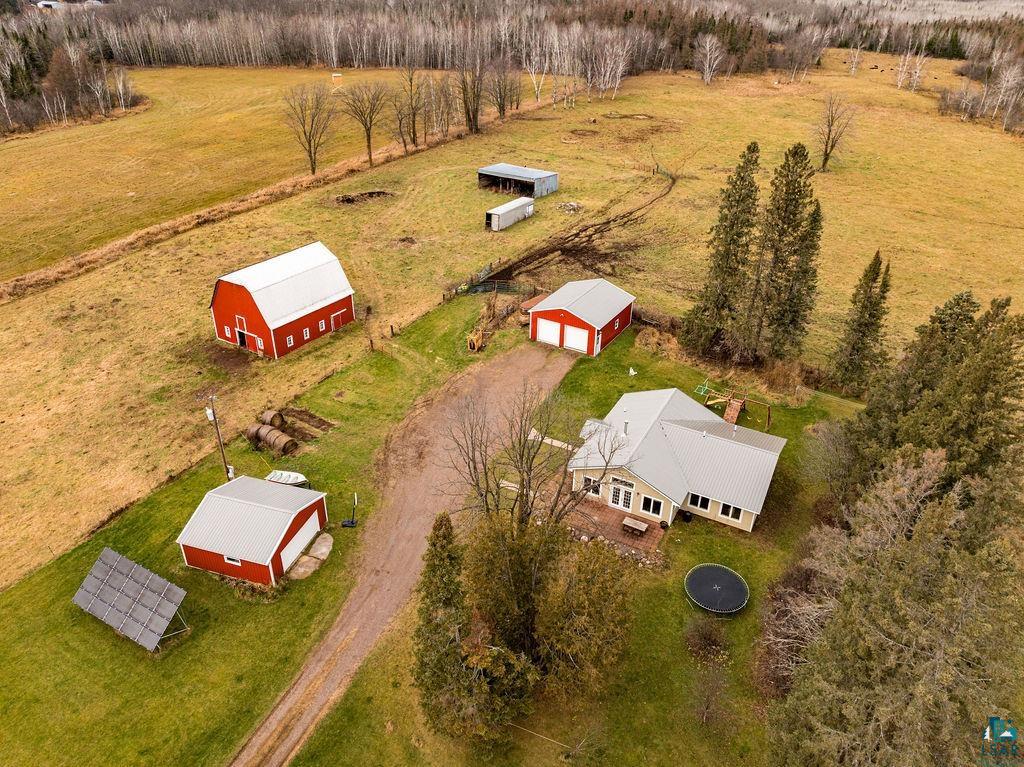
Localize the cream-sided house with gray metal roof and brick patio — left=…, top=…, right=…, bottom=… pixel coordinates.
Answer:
left=569, top=389, right=786, bottom=531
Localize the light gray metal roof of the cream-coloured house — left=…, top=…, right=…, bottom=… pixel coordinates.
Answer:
left=569, top=389, right=785, bottom=514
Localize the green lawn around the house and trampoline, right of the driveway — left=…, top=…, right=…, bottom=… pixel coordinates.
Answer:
left=296, top=331, right=854, bottom=767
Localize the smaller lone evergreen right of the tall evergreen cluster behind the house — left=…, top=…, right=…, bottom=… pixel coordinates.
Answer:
left=829, top=251, right=890, bottom=394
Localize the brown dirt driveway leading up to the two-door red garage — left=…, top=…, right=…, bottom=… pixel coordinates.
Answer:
left=231, top=344, right=572, bottom=767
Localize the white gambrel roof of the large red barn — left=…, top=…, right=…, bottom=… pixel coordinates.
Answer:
left=220, top=242, right=354, bottom=330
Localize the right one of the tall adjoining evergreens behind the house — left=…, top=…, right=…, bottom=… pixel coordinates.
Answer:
left=735, top=143, right=821, bottom=361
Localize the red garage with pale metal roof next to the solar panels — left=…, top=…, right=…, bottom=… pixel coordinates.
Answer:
left=177, top=476, right=327, bottom=586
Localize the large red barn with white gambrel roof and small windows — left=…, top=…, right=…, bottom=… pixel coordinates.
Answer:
left=210, top=243, right=355, bottom=359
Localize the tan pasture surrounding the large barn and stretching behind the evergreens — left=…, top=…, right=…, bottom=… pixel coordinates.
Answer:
left=0, top=47, right=1024, bottom=585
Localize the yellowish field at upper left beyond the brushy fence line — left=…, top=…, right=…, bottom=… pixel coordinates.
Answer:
left=0, top=68, right=403, bottom=281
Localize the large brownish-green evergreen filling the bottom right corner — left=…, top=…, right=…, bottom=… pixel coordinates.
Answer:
left=774, top=481, right=1024, bottom=767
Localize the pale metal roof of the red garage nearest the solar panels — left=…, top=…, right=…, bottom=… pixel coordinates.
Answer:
left=177, top=476, right=326, bottom=564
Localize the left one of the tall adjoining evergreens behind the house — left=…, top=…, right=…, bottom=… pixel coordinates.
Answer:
left=684, top=141, right=761, bottom=354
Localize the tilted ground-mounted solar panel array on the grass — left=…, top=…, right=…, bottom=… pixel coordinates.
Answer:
left=72, top=548, right=185, bottom=652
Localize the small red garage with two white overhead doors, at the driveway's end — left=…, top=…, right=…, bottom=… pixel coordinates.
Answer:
left=529, top=280, right=636, bottom=356
